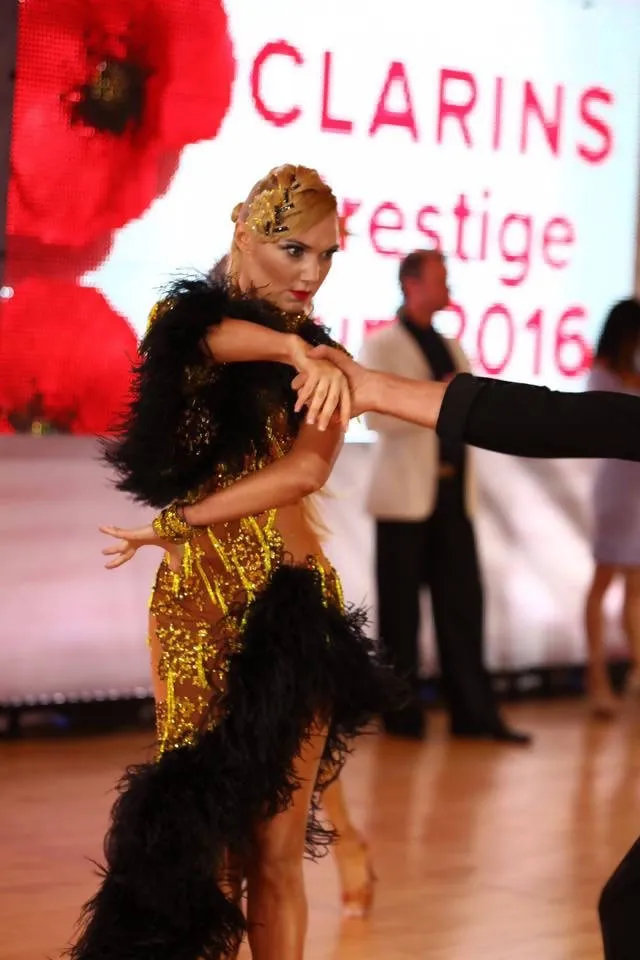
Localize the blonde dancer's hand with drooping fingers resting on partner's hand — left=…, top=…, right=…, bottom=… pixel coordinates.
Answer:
left=292, top=340, right=351, bottom=430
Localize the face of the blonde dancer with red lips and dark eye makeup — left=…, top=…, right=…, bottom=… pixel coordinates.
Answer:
left=236, top=214, right=339, bottom=313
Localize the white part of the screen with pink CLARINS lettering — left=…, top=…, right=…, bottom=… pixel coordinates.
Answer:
left=85, top=0, right=640, bottom=408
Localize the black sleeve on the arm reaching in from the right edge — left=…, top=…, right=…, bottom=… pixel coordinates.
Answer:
left=436, top=373, right=640, bottom=460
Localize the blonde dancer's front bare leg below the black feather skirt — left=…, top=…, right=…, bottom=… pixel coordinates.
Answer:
left=247, top=731, right=326, bottom=960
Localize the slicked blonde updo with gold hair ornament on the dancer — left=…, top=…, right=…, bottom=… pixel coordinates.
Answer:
left=227, top=163, right=338, bottom=281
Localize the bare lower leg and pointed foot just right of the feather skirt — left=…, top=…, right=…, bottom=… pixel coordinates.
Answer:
left=322, top=779, right=374, bottom=917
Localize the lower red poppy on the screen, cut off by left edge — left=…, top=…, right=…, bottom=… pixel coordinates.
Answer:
left=0, top=277, right=137, bottom=434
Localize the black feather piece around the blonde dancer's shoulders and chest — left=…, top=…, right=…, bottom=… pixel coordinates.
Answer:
left=104, top=278, right=334, bottom=507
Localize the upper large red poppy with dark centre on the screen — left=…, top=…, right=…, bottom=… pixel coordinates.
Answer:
left=8, top=0, right=235, bottom=247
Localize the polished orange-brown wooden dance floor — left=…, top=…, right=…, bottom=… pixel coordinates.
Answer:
left=0, top=702, right=640, bottom=960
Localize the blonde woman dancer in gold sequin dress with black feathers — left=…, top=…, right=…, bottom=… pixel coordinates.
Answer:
left=71, top=166, right=391, bottom=960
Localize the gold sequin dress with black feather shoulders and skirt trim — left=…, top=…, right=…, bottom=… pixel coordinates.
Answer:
left=70, top=280, right=393, bottom=960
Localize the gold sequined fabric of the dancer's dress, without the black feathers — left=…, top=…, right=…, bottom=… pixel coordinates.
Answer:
left=150, top=402, right=342, bottom=754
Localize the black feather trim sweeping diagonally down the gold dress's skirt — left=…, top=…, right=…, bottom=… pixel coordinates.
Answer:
left=62, top=566, right=397, bottom=960
